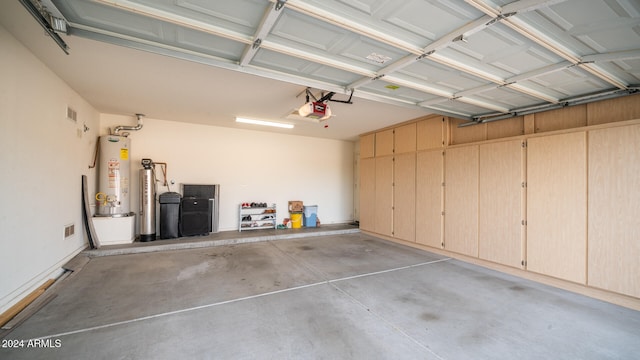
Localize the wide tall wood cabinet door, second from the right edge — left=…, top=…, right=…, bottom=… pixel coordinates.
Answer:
left=527, top=132, right=587, bottom=284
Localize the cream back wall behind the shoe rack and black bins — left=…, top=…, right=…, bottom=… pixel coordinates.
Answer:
left=100, top=114, right=354, bottom=231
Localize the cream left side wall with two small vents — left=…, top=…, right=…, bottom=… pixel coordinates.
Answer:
left=0, top=26, right=99, bottom=313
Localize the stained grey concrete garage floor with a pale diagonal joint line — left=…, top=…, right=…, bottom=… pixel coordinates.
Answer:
left=0, top=232, right=640, bottom=359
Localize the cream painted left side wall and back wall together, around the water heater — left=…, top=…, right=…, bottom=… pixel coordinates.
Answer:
left=0, top=22, right=354, bottom=313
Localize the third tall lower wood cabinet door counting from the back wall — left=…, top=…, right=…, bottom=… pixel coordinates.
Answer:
left=393, top=153, right=416, bottom=241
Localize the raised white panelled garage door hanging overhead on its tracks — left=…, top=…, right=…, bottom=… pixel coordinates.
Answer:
left=10, top=0, right=640, bottom=140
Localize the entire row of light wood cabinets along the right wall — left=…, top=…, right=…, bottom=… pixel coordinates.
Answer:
left=359, top=94, right=640, bottom=302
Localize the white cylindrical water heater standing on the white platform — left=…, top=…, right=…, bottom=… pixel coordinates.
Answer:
left=96, top=135, right=132, bottom=217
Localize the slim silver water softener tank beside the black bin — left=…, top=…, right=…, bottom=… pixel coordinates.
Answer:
left=140, top=159, right=156, bottom=241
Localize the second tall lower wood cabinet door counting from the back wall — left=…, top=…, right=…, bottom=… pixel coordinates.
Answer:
left=374, top=156, right=393, bottom=236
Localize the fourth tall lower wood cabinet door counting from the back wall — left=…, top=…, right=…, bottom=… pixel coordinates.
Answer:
left=416, top=150, right=444, bottom=248
